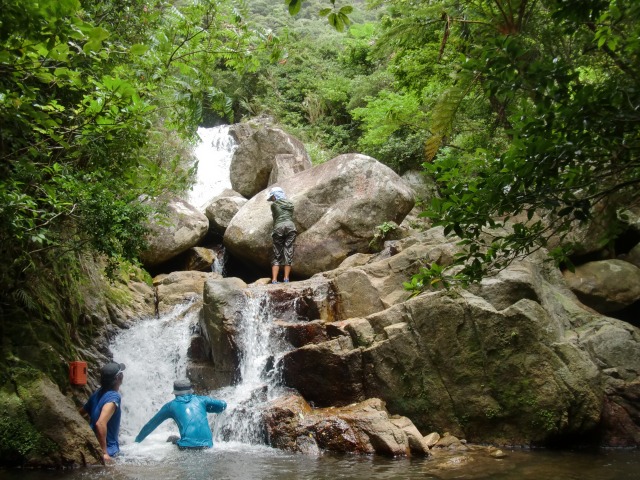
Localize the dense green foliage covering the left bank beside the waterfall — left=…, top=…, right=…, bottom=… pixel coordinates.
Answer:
left=0, top=0, right=277, bottom=373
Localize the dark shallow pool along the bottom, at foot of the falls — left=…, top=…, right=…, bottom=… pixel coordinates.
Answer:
left=0, top=448, right=640, bottom=480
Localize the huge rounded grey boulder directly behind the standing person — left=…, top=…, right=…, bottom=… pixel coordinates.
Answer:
left=224, top=154, right=414, bottom=277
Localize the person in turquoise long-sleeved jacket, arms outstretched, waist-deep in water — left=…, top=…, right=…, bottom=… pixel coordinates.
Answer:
left=136, top=379, right=227, bottom=449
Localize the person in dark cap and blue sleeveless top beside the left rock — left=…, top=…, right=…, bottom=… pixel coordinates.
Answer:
left=80, top=362, right=125, bottom=463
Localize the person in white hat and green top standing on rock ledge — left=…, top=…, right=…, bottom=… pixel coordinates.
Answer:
left=267, top=187, right=298, bottom=283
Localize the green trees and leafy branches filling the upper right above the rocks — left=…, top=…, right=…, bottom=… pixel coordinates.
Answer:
left=268, top=0, right=640, bottom=291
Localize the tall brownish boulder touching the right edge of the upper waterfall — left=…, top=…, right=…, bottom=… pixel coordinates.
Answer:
left=229, top=127, right=311, bottom=198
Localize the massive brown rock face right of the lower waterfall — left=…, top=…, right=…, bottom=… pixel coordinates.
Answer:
left=205, top=228, right=640, bottom=449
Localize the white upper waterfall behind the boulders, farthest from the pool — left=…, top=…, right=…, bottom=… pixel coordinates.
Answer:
left=187, top=125, right=237, bottom=212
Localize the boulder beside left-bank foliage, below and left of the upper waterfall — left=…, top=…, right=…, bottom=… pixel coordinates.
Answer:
left=140, top=198, right=209, bottom=267
